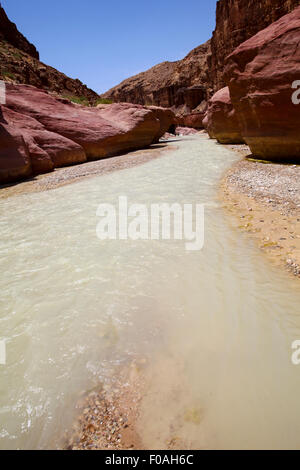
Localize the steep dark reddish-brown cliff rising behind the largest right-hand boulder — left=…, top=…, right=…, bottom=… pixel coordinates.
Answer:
left=209, top=0, right=300, bottom=91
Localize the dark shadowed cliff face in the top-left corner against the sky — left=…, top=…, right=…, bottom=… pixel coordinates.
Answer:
left=0, top=4, right=39, bottom=60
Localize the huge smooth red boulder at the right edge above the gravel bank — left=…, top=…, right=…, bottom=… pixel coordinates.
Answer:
left=225, top=7, right=300, bottom=161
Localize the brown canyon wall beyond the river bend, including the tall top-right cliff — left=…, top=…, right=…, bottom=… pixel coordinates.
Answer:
left=103, top=0, right=300, bottom=116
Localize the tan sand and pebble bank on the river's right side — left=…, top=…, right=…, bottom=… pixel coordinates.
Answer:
left=220, top=145, right=300, bottom=277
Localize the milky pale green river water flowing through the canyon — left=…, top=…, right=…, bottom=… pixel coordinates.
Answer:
left=0, top=136, right=300, bottom=449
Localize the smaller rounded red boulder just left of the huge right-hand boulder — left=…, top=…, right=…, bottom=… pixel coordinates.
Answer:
left=204, top=87, right=244, bottom=144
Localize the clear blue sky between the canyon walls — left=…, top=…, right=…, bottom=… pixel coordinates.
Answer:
left=2, top=0, right=216, bottom=93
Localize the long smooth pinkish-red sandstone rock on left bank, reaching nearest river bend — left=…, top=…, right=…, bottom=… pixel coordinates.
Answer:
left=6, top=84, right=160, bottom=160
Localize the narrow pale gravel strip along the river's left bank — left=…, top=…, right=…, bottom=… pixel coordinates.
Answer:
left=0, top=142, right=174, bottom=199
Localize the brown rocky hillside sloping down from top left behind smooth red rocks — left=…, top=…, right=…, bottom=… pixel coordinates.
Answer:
left=0, top=7, right=99, bottom=105
